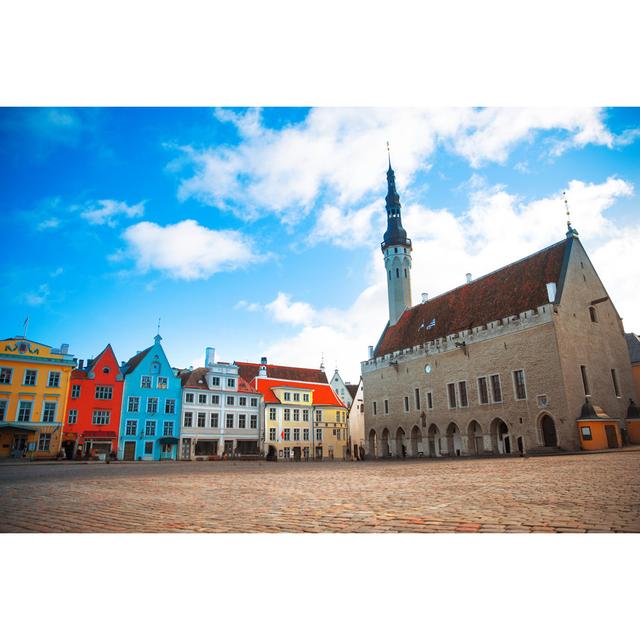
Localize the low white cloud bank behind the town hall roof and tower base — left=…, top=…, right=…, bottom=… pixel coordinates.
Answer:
left=238, top=177, right=640, bottom=380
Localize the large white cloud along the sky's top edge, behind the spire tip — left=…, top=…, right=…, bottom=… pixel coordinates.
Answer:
left=172, top=108, right=615, bottom=224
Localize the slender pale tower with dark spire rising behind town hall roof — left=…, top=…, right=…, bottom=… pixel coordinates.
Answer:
left=381, top=150, right=411, bottom=325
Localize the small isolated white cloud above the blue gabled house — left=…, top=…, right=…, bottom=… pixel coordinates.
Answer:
left=117, top=220, right=265, bottom=280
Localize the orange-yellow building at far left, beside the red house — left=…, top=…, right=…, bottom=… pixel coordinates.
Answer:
left=0, top=338, right=74, bottom=458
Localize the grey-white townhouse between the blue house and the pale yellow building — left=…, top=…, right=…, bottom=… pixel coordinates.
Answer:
left=180, top=347, right=263, bottom=460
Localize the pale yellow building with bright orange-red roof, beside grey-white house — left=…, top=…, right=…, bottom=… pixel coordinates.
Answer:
left=254, top=376, right=349, bottom=460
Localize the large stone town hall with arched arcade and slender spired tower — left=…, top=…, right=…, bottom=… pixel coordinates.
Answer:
left=362, top=158, right=634, bottom=457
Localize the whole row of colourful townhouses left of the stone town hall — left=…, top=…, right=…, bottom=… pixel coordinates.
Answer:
left=0, top=335, right=351, bottom=461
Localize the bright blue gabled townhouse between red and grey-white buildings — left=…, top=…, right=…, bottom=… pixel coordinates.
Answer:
left=118, top=335, right=182, bottom=460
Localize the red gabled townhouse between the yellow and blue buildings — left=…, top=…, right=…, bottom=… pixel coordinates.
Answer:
left=62, top=344, right=123, bottom=458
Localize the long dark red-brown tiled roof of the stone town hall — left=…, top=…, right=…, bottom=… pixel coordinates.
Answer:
left=374, top=240, right=569, bottom=357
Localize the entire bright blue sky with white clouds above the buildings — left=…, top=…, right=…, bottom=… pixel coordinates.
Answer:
left=0, top=108, right=640, bottom=378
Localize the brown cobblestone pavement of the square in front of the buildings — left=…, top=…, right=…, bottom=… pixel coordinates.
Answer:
left=0, top=451, right=640, bottom=532
